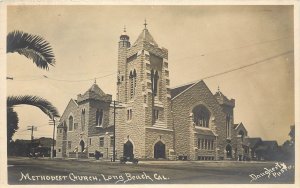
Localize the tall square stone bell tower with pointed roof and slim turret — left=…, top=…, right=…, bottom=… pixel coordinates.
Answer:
left=117, top=21, right=173, bottom=158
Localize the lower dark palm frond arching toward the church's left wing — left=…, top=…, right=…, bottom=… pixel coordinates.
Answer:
left=7, top=95, right=59, bottom=119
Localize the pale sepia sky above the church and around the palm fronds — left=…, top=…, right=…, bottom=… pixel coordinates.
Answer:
left=7, top=5, right=295, bottom=144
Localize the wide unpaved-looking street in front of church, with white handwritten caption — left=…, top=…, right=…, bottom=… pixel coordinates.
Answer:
left=8, top=158, right=294, bottom=184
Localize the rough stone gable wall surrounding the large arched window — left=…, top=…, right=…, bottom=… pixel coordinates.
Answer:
left=172, top=81, right=226, bottom=160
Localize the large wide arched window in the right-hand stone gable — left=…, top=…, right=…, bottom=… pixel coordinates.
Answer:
left=193, top=105, right=210, bottom=127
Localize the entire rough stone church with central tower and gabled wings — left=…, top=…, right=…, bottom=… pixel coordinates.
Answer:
left=56, top=24, right=251, bottom=160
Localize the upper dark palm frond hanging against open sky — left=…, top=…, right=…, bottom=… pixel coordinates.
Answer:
left=6, top=31, right=55, bottom=70
